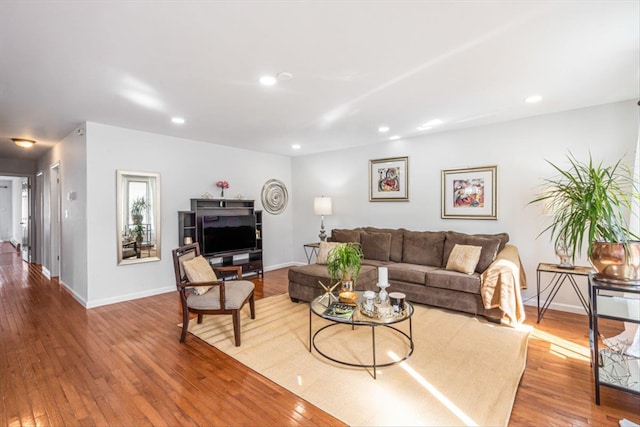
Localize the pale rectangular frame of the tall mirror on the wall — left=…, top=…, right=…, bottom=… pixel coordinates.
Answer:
left=116, top=170, right=162, bottom=265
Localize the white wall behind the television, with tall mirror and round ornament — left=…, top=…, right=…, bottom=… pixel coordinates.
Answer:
left=86, top=123, right=294, bottom=307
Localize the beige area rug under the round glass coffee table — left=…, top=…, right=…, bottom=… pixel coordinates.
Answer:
left=189, top=295, right=529, bottom=426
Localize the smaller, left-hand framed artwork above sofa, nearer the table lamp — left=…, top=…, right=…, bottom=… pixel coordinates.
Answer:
left=369, top=157, right=409, bottom=202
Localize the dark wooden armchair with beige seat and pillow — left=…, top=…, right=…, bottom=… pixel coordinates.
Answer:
left=173, top=242, right=256, bottom=347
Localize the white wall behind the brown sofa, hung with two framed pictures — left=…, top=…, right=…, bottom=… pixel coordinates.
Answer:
left=292, top=100, right=638, bottom=314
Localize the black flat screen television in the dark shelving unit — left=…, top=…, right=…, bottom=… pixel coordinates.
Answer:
left=201, top=215, right=257, bottom=255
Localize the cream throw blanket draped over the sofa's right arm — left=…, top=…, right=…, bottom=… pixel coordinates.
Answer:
left=480, top=245, right=527, bottom=326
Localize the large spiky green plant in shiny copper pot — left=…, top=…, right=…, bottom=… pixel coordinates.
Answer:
left=530, top=153, right=640, bottom=283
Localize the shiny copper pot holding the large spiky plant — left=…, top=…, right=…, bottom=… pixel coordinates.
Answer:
left=589, top=241, right=640, bottom=285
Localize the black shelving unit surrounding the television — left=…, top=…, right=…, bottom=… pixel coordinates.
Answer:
left=178, top=199, right=264, bottom=279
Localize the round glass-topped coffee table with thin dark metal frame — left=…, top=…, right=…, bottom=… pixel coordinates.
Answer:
left=309, top=291, right=414, bottom=379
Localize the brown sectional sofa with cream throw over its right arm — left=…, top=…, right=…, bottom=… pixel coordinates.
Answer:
left=289, top=227, right=526, bottom=324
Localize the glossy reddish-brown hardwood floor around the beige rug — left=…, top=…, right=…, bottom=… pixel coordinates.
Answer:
left=0, top=243, right=640, bottom=426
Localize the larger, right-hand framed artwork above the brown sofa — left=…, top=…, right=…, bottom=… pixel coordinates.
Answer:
left=441, top=166, right=498, bottom=219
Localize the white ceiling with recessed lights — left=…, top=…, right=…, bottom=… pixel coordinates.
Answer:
left=0, top=0, right=640, bottom=162
